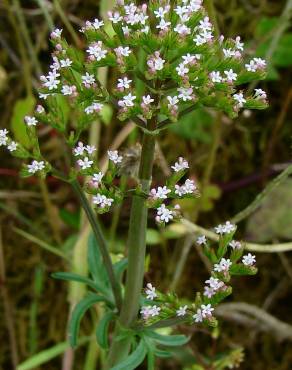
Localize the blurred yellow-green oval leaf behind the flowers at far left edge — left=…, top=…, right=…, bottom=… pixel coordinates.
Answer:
left=10, top=95, right=35, bottom=149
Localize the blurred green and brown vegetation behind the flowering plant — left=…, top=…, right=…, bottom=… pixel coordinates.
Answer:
left=0, top=0, right=292, bottom=370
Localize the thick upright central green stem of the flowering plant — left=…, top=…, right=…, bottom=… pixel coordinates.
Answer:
left=108, top=130, right=155, bottom=368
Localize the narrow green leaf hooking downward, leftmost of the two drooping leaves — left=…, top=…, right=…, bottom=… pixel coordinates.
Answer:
left=68, top=294, right=104, bottom=348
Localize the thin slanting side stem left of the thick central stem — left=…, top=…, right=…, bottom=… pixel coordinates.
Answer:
left=70, top=180, right=122, bottom=310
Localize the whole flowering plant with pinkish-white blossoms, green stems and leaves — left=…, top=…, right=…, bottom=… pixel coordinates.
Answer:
left=0, top=0, right=267, bottom=370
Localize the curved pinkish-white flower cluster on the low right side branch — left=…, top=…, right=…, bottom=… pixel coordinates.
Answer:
left=140, top=221, right=257, bottom=326
